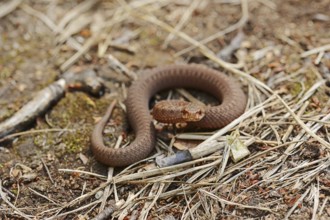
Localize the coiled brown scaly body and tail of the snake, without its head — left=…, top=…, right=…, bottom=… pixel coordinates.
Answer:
left=91, top=64, right=246, bottom=167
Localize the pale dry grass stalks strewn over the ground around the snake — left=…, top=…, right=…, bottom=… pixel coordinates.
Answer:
left=0, top=0, right=330, bottom=219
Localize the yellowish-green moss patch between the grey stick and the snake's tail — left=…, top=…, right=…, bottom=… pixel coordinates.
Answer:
left=35, top=92, right=113, bottom=156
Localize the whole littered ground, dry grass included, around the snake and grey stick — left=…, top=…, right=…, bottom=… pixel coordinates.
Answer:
left=0, top=0, right=330, bottom=220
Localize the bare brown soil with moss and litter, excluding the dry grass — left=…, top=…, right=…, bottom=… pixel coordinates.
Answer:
left=0, top=0, right=330, bottom=219
